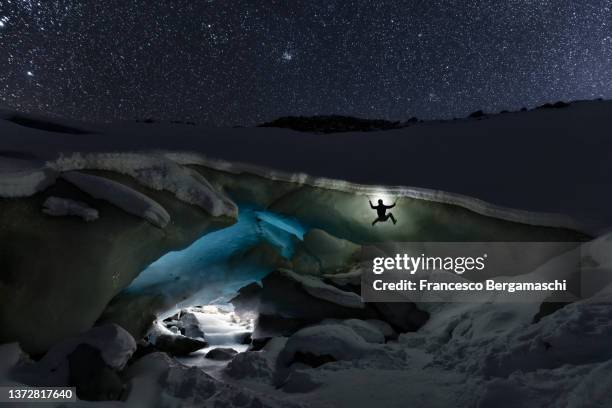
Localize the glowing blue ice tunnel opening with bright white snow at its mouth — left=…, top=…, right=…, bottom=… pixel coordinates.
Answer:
left=124, top=205, right=306, bottom=368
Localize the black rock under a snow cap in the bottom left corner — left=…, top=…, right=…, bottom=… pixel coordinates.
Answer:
left=68, top=344, right=124, bottom=401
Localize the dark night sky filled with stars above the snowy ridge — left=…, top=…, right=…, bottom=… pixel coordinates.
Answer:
left=0, top=0, right=612, bottom=126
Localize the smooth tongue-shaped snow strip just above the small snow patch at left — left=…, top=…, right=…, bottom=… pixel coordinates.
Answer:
left=61, top=171, right=170, bottom=228
